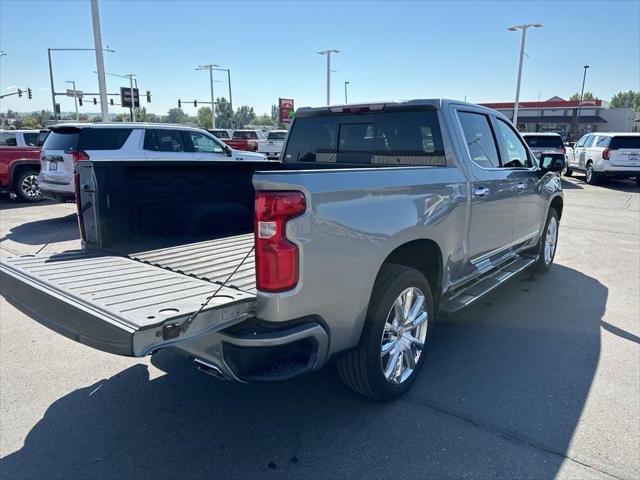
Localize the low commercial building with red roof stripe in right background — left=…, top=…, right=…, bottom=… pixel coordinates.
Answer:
left=481, top=97, right=638, bottom=140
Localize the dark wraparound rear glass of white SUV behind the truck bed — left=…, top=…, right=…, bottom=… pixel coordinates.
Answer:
left=42, top=128, right=132, bottom=150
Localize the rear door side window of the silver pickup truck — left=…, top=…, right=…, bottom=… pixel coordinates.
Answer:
left=458, top=112, right=500, bottom=168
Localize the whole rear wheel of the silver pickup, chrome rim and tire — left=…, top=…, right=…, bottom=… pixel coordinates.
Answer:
left=338, top=264, right=434, bottom=401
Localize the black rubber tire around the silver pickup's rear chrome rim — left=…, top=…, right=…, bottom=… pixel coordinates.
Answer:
left=337, top=264, right=435, bottom=402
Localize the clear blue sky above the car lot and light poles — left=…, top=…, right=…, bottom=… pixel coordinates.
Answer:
left=0, top=0, right=640, bottom=114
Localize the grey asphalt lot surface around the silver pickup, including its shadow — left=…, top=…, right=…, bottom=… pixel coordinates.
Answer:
left=0, top=177, right=640, bottom=479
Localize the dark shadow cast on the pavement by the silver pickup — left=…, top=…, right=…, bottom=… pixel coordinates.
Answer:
left=0, top=265, right=608, bottom=479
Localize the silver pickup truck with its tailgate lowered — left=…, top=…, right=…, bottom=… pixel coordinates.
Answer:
left=0, top=100, right=563, bottom=400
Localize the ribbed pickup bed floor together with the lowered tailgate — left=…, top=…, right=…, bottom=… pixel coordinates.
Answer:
left=0, top=234, right=255, bottom=356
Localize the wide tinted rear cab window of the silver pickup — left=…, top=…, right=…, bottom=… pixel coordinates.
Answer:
left=284, top=111, right=446, bottom=166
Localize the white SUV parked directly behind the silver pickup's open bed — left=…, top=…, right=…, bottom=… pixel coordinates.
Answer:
left=38, top=123, right=266, bottom=201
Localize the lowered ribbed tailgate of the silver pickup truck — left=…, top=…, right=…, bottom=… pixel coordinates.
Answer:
left=0, top=251, right=255, bottom=356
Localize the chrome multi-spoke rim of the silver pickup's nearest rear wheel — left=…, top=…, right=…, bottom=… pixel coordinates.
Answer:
left=380, top=287, right=429, bottom=384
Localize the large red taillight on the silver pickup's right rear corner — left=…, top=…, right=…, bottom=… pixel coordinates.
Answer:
left=255, top=192, right=306, bottom=292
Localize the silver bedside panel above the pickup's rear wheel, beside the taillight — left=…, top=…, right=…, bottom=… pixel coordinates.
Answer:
left=253, top=167, right=468, bottom=353
